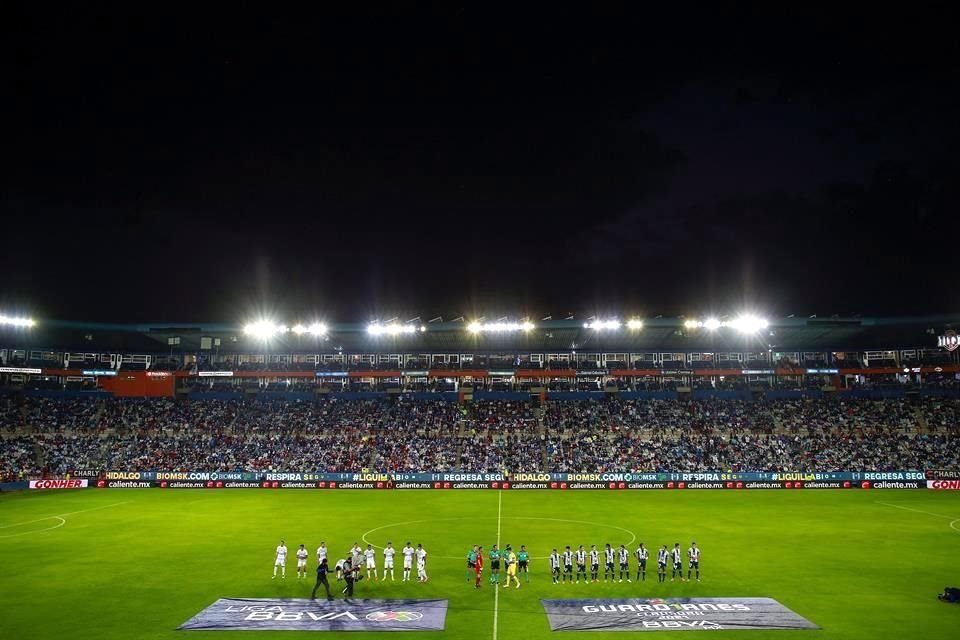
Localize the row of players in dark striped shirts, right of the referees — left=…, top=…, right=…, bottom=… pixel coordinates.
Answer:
left=549, top=542, right=700, bottom=584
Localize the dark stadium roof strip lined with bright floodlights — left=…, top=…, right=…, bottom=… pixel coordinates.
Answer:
left=7, top=313, right=960, bottom=353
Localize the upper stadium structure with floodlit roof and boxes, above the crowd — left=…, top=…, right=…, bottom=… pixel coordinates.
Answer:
left=0, top=314, right=960, bottom=399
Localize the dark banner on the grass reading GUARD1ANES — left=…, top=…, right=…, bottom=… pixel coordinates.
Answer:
left=541, top=598, right=819, bottom=631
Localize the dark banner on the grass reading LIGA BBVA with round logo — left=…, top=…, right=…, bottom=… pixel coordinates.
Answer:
left=178, top=598, right=447, bottom=631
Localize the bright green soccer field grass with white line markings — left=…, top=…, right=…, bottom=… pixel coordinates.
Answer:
left=0, top=489, right=960, bottom=640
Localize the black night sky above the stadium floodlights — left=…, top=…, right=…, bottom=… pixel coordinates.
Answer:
left=0, top=3, right=960, bottom=322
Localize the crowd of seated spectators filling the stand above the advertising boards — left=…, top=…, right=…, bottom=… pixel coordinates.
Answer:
left=0, top=396, right=960, bottom=478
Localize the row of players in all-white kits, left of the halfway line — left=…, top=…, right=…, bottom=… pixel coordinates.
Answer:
left=271, top=540, right=430, bottom=582
